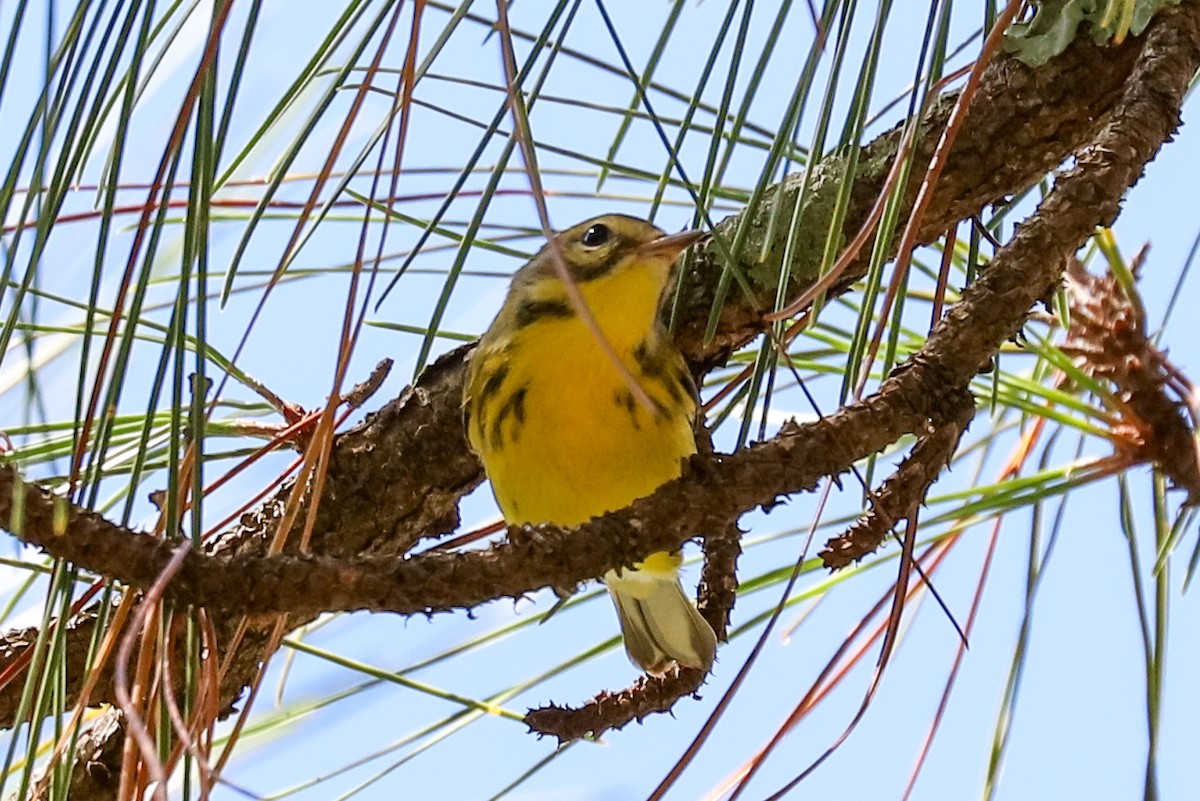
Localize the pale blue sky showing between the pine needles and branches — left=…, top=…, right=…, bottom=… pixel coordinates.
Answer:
left=0, top=0, right=1200, bottom=801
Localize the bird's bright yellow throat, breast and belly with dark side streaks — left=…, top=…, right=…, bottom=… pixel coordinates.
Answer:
left=468, top=256, right=696, bottom=525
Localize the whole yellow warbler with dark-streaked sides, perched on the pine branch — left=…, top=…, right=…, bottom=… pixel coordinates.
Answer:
left=463, top=215, right=716, bottom=674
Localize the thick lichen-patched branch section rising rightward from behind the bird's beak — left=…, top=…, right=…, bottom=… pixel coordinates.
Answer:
left=677, top=17, right=1146, bottom=366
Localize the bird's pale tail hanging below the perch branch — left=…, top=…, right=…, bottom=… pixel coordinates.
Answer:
left=605, top=553, right=716, bottom=675
